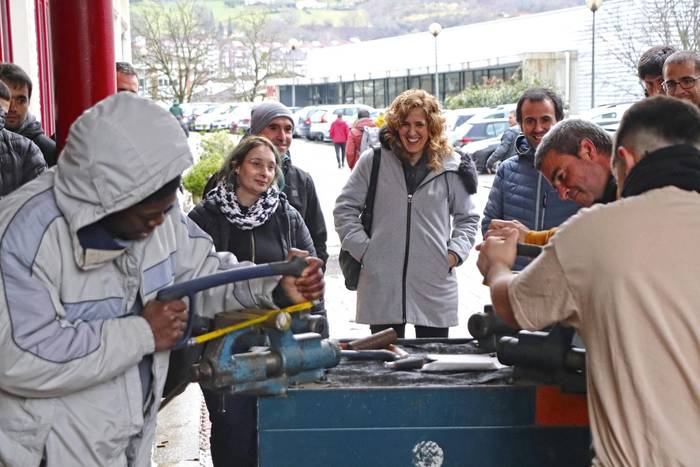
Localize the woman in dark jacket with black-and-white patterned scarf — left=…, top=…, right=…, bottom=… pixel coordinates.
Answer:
left=189, top=136, right=316, bottom=467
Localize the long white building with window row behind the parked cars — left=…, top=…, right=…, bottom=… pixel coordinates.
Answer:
left=276, top=0, right=680, bottom=114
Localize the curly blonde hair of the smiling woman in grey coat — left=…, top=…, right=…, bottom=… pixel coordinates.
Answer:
left=384, top=89, right=452, bottom=170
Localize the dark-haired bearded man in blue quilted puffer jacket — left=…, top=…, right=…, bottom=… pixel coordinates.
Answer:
left=481, top=88, right=579, bottom=270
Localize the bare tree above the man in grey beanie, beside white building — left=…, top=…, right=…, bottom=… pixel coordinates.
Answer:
left=230, top=10, right=291, bottom=101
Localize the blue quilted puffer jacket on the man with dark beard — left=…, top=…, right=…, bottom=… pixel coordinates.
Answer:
left=481, top=135, right=580, bottom=270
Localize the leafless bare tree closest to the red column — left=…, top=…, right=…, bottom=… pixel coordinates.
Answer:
left=134, top=0, right=216, bottom=102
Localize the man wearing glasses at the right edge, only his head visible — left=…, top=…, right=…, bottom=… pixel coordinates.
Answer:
left=661, top=52, right=700, bottom=107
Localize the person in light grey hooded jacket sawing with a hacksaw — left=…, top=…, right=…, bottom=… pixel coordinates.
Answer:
left=0, top=93, right=323, bottom=467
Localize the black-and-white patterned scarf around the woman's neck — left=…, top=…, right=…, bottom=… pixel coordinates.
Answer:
left=207, top=182, right=280, bottom=230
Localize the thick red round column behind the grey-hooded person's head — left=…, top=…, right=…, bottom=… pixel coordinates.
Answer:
left=49, top=0, right=116, bottom=150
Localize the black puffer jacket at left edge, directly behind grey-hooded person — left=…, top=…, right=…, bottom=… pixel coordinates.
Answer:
left=0, top=127, right=46, bottom=197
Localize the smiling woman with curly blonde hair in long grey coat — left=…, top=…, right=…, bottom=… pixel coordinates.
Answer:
left=333, top=89, right=479, bottom=337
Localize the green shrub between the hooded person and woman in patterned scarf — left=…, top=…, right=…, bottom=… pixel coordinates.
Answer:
left=182, top=131, right=236, bottom=203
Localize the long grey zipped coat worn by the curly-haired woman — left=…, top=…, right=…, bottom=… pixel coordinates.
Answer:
left=333, top=143, right=479, bottom=327
